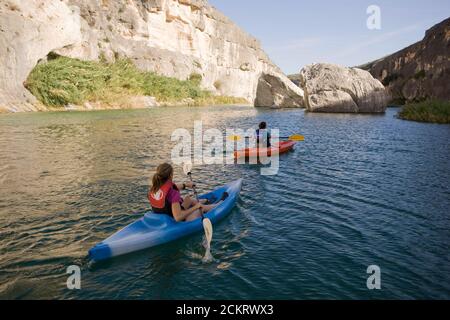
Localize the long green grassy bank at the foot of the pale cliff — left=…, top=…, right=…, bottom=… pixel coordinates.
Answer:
left=26, top=57, right=248, bottom=107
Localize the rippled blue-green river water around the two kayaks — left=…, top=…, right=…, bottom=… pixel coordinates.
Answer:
left=0, top=107, right=450, bottom=299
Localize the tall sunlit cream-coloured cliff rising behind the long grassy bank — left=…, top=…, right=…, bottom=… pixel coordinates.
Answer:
left=0, top=0, right=303, bottom=111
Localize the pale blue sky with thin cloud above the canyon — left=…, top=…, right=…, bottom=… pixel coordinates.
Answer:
left=209, top=0, right=450, bottom=74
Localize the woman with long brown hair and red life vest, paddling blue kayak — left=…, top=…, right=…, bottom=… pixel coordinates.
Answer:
left=148, top=163, right=224, bottom=222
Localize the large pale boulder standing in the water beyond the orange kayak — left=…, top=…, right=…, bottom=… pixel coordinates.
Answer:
left=300, top=63, right=389, bottom=113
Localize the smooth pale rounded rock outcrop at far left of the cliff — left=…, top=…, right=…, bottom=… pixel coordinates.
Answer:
left=0, top=1, right=81, bottom=111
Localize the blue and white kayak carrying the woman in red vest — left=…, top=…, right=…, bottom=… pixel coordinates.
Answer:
left=89, top=179, right=242, bottom=261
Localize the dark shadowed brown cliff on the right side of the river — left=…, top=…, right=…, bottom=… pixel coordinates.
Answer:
left=363, top=18, right=450, bottom=103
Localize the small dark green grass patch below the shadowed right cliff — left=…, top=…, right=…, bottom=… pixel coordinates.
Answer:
left=398, top=100, right=450, bottom=123
